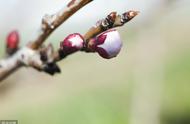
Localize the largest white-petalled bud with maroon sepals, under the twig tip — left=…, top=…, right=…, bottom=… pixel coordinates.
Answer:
left=89, top=29, right=122, bottom=59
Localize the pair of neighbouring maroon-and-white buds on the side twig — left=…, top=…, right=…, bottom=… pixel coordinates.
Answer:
left=59, top=29, right=122, bottom=59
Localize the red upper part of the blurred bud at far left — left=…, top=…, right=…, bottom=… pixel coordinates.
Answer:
left=6, top=31, right=20, bottom=49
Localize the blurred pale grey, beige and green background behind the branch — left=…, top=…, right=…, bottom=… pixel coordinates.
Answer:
left=0, top=0, right=190, bottom=124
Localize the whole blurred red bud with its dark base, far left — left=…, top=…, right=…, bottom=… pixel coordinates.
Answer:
left=6, top=31, right=20, bottom=55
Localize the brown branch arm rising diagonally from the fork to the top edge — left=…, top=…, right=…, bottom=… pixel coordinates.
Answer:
left=31, top=0, right=93, bottom=49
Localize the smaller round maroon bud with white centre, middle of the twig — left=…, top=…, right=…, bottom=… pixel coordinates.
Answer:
left=60, top=33, right=84, bottom=53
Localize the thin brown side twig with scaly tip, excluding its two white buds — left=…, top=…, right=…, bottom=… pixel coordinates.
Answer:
left=54, top=11, right=139, bottom=62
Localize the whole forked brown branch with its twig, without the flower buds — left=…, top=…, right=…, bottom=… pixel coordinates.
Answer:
left=0, top=0, right=138, bottom=81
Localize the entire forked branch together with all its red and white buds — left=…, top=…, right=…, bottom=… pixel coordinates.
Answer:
left=0, top=0, right=138, bottom=81
